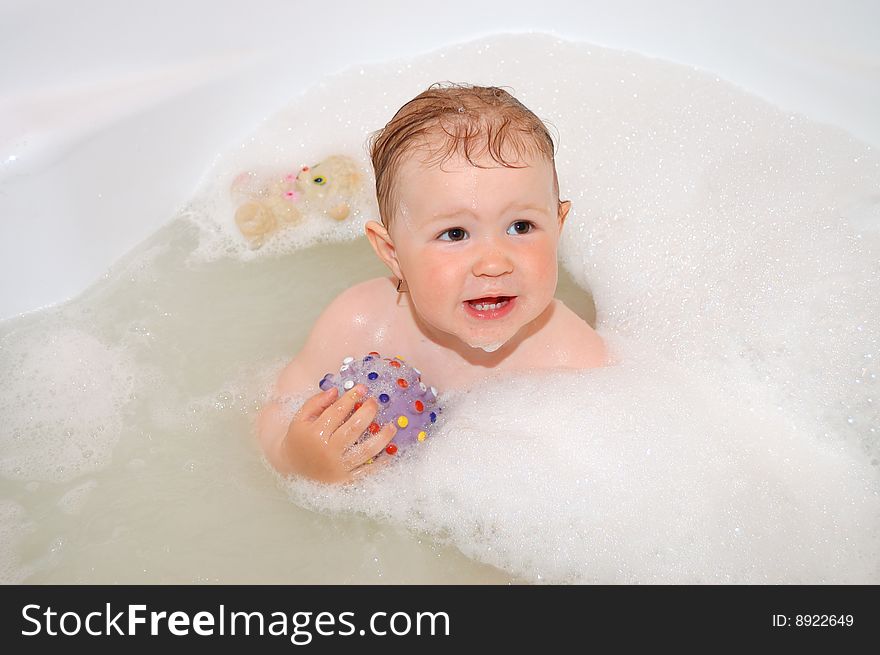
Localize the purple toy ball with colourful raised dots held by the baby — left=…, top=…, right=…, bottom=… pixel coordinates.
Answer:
left=318, top=352, right=442, bottom=455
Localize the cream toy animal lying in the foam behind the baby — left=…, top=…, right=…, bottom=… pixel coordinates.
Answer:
left=231, top=155, right=364, bottom=248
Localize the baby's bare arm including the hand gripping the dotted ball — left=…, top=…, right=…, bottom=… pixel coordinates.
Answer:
left=257, top=288, right=397, bottom=482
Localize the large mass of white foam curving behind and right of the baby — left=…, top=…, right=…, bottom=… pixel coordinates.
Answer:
left=260, top=35, right=880, bottom=583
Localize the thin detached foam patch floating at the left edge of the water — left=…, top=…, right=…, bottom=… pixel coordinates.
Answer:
left=0, top=321, right=135, bottom=482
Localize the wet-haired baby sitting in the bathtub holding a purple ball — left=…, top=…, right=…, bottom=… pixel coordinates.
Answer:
left=258, top=84, right=606, bottom=482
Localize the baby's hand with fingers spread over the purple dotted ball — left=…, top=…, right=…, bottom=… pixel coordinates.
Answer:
left=281, top=384, right=397, bottom=482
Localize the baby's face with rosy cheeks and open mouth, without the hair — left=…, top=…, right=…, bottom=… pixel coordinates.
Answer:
left=390, top=149, right=569, bottom=351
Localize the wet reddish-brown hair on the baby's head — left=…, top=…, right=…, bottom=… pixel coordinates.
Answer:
left=369, top=82, right=559, bottom=229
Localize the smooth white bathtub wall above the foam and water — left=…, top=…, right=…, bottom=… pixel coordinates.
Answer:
left=0, top=0, right=880, bottom=318
